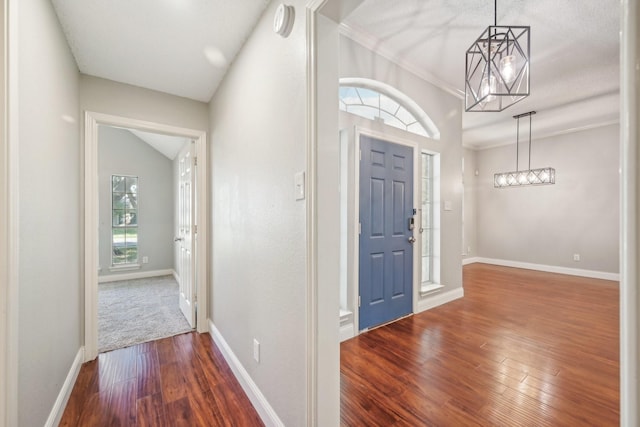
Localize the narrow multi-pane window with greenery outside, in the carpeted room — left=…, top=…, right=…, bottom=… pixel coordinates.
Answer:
left=111, top=175, right=138, bottom=266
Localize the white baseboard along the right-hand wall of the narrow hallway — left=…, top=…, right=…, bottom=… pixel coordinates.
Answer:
left=208, top=319, right=284, bottom=427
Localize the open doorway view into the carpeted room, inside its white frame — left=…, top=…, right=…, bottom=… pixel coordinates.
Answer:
left=98, top=125, right=195, bottom=353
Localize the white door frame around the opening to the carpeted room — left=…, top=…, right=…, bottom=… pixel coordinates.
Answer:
left=84, top=111, right=209, bottom=361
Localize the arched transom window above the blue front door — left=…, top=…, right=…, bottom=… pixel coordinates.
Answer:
left=340, top=78, right=440, bottom=139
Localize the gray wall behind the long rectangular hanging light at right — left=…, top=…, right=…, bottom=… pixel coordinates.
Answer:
left=476, top=120, right=620, bottom=273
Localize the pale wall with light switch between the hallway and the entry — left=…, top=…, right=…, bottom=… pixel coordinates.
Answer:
left=210, top=0, right=310, bottom=426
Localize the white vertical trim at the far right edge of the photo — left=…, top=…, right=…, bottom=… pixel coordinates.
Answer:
left=620, top=0, right=640, bottom=427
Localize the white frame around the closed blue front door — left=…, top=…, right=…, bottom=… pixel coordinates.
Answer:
left=351, top=126, right=422, bottom=336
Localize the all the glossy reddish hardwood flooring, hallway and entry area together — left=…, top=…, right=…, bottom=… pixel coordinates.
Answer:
left=60, top=264, right=619, bottom=427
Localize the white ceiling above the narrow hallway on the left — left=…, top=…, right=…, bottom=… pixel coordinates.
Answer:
left=52, top=0, right=269, bottom=102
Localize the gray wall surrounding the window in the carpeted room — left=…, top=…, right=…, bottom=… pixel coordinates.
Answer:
left=98, top=126, right=175, bottom=276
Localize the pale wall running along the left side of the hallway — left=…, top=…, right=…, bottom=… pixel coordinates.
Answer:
left=18, top=0, right=82, bottom=426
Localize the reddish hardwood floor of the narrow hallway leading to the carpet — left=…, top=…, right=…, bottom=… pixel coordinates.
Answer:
left=60, top=333, right=263, bottom=427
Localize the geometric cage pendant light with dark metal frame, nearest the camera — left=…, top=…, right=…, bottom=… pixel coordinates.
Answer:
left=464, top=0, right=531, bottom=111
